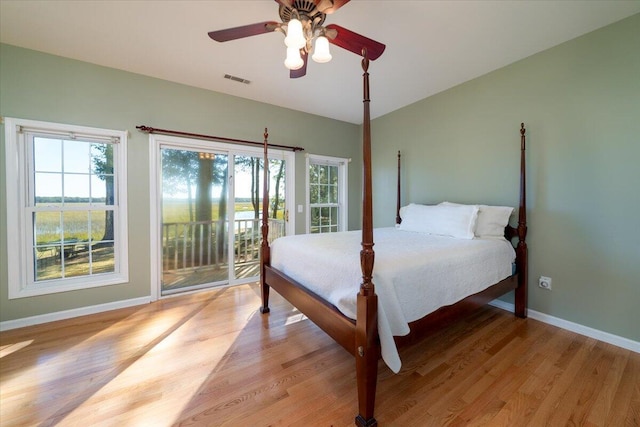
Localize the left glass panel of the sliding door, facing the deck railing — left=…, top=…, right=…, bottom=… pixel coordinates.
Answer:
left=160, top=148, right=229, bottom=294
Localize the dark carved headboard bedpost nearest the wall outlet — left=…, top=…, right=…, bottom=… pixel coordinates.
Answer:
left=515, top=123, right=529, bottom=317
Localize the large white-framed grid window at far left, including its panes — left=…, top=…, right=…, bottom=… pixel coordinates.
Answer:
left=5, top=118, right=128, bottom=298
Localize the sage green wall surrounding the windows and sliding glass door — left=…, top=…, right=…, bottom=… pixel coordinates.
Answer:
left=0, top=45, right=362, bottom=321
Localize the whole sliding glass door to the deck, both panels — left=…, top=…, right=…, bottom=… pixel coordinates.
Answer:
left=157, top=141, right=294, bottom=295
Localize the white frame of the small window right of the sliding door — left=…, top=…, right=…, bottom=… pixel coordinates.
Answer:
left=305, top=154, right=351, bottom=234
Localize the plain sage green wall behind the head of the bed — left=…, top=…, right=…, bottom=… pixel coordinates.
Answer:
left=372, top=15, right=640, bottom=341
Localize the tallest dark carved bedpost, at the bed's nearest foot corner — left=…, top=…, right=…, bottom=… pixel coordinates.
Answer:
left=355, top=49, right=380, bottom=427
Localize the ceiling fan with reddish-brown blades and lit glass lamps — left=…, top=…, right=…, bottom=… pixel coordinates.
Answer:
left=209, top=0, right=386, bottom=78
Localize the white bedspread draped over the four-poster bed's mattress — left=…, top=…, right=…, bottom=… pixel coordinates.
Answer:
left=271, top=228, right=515, bottom=372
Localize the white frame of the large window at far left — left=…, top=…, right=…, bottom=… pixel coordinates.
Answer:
left=4, top=117, right=129, bottom=299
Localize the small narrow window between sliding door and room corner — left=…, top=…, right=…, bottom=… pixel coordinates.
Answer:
left=307, top=155, right=349, bottom=233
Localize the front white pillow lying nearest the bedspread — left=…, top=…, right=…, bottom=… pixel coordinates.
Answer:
left=398, top=203, right=478, bottom=239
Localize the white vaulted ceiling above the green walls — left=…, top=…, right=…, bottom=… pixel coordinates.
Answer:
left=0, top=0, right=640, bottom=124
